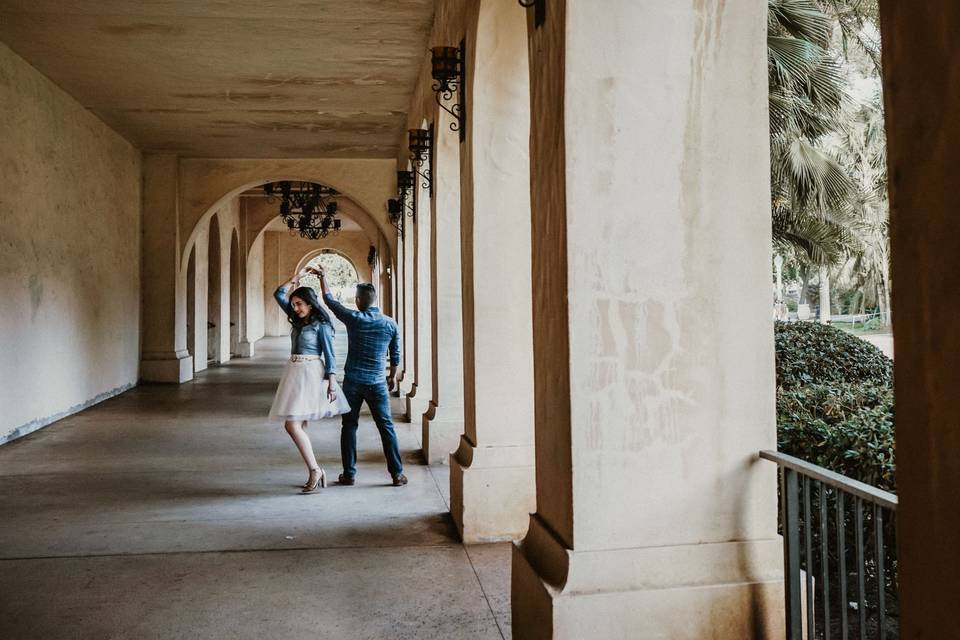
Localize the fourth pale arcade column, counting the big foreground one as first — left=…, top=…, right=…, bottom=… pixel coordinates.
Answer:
left=404, top=182, right=433, bottom=422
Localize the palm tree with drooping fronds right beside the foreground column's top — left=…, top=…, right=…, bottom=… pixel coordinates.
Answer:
left=767, top=0, right=858, bottom=267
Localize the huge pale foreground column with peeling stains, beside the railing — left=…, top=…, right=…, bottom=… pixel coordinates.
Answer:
left=512, top=0, right=784, bottom=640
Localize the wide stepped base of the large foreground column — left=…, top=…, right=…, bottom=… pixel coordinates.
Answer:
left=511, top=515, right=785, bottom=640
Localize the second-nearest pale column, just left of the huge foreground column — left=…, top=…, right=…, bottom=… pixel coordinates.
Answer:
left=450, top=0, right=535, bottom=542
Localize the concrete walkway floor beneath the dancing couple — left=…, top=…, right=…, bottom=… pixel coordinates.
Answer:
left=0, top=339, right=511, bottom=640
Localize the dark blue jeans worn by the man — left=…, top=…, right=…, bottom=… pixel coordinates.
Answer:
left=340, top=378, right=403, bottom=478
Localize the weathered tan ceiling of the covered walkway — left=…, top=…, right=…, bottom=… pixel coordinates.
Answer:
left=0, top=0, right=434, bottom=158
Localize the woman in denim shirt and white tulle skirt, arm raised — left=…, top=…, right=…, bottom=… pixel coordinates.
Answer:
left=270, top=268, right=350, bottom=493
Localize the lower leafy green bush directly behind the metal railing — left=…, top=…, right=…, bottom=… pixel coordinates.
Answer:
left=777, top=383, right=896, bottom=491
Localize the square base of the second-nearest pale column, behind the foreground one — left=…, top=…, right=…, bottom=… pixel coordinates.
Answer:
left=450, top=436, right=537, bottom=544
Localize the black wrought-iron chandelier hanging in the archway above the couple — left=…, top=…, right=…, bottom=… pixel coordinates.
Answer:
left=263, top=180, right=341, bottom=240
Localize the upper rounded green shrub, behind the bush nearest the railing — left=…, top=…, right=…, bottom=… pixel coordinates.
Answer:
left=774, top=322, right=893, bottom=389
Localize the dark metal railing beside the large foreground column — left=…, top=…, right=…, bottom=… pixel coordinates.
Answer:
left=760, top=451, right=899, bottom=640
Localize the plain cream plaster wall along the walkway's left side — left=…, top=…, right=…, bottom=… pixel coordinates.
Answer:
left=0, top=45, right=141, bottom=442
